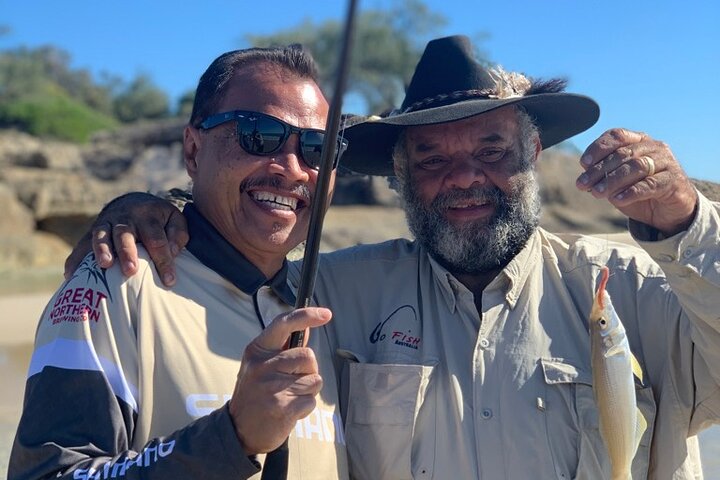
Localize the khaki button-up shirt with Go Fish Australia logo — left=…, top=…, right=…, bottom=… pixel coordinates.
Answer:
left=300, top=192, right=720, bottom=480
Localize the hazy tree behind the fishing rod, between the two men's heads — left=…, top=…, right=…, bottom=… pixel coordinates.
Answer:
left=245, top=0, right=447, bottom=113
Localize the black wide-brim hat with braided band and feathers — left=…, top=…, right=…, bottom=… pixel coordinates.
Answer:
left=341, top=35, right=600, bottom=175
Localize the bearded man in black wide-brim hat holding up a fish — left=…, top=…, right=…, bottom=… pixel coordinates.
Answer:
left=67, top=37, right=720, bottom=479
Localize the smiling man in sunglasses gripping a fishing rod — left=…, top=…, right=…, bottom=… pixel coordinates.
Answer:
left=9, top=46, right=347, bottom=479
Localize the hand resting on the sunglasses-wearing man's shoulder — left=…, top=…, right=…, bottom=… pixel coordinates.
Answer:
left=65, top=192, right=189, bottom=286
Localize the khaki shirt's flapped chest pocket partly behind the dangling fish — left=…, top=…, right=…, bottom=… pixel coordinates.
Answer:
left=540, top=358, right=656, bottom=480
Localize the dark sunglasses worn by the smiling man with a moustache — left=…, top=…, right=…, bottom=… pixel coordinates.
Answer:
left=200, top=110, right=348, bottom=170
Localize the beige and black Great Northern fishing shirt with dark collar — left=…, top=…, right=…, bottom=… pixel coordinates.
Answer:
left=8, top=206, right=348, bottom=480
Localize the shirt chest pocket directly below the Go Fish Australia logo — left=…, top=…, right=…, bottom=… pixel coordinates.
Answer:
left=345, top=363, right=434, bottom=480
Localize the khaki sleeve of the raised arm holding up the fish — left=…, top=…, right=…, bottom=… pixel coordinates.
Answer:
left=630, top=194, right=720, bottom=434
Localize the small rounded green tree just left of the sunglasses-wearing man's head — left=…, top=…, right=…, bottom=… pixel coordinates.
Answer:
left=113, top=74, right=170, bottom=122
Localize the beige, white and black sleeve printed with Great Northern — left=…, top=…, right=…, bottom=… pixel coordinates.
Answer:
left=8, top=254, right=260, bottom=480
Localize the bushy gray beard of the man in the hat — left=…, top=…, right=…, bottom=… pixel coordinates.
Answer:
left=399, top=170, right=540, bottom=275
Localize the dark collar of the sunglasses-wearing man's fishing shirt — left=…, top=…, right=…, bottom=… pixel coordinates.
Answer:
left=183, top=203, right=295, bottom=305
